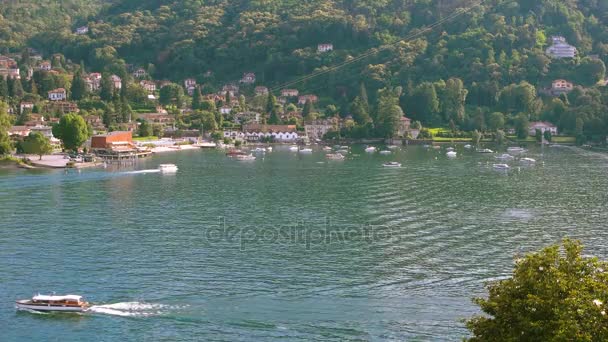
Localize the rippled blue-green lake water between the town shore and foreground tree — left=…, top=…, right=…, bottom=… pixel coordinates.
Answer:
left=0, top=147, right=608, bottom=341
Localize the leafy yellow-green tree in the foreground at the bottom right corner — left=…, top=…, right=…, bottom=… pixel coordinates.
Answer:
left=467, top=239, right=608, bottom=341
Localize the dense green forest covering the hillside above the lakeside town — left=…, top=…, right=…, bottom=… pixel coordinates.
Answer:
left=0, top=0, right=608, bottom=138
